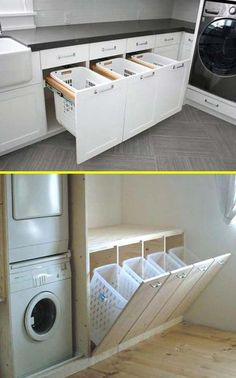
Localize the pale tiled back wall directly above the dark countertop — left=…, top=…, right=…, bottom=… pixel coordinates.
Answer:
left=34, top=0, right=174, bottom=26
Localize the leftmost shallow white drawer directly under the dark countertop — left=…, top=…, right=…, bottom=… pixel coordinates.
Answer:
left=40, top=45, right=89, bottom=70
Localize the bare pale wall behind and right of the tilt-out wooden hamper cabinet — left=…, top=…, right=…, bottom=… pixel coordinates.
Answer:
left=122, top=175, right=236, bottom=331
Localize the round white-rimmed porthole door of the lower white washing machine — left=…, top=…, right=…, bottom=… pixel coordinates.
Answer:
left=25, top=292, right=61, bottom=341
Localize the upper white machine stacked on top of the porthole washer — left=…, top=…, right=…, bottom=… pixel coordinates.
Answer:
left=6, top=174, right=68, bottom=263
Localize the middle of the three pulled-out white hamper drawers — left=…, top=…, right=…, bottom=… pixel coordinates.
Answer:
left=93, top=58, right=156, bottom=140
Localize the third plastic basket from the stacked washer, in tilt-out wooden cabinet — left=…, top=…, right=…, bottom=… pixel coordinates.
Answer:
left=147, top=252, right=185, bottom=272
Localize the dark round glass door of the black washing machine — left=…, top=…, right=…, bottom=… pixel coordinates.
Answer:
left=199, top=18, right=236, bottom=76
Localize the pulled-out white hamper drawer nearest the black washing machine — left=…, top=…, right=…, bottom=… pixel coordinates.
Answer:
left=131, top=53, right=190, bottom=123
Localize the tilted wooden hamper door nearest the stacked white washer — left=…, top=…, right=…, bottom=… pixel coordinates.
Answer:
left=94, top=273, right=169, bottom=355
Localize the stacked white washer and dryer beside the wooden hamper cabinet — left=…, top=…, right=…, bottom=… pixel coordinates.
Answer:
left=7, top=175, right=72, bottom=377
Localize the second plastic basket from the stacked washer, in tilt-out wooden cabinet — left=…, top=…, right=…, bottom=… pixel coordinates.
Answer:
left=123, top=257, right=165, bottom=284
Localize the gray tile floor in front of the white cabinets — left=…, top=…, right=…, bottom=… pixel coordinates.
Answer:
left=0, top=105, right=236, bottom=171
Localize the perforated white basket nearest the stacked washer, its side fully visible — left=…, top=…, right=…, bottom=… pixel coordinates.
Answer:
left=90, top=264, right=139, bottom=345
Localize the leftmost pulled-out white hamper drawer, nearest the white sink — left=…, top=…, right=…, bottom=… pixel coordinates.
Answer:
left=46, top=67, right=126, bottom=164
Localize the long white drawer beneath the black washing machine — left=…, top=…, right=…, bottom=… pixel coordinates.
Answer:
left=187, top=88, right=236, bottom=119
